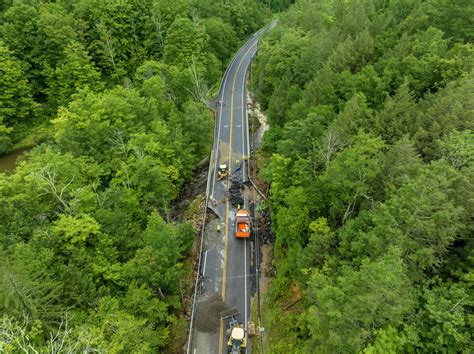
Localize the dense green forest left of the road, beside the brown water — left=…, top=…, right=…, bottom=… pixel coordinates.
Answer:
left=0, top=0, right=272, bottom=353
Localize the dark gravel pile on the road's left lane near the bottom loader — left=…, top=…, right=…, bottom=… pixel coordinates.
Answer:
left=195, top=295, right=230, bottom=333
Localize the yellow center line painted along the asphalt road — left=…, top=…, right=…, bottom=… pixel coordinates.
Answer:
left=219, top=42, right=257, bottom=353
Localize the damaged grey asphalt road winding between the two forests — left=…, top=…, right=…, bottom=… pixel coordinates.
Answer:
left=187, top=24, right=264, bottom=354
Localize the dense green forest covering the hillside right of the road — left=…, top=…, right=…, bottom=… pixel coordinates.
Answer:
left=253, top=0, right=474, bottom=353
